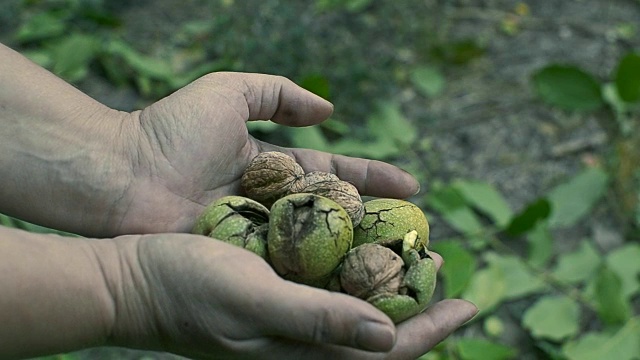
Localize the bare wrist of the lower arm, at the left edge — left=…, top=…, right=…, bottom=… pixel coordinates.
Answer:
left=0, top=227, right=115, bottom=357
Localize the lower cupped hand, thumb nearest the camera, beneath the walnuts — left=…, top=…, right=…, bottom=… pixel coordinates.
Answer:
left=102, top=234, right=477, bottom=359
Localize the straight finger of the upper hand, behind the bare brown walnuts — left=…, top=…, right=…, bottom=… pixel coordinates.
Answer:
left=256, top=140, right=420, bottom=199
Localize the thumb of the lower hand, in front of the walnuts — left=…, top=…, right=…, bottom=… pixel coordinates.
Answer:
left=264, top=282, right=396, bottom=352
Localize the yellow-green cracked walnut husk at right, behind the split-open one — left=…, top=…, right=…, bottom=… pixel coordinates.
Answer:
left=353, top=199, right=429, bottom=247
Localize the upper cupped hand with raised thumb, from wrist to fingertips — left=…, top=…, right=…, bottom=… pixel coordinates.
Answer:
left=111, top=73, right=419, bottom=234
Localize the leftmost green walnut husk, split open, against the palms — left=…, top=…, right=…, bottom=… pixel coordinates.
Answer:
left=192, top=196, right=269, bottom=261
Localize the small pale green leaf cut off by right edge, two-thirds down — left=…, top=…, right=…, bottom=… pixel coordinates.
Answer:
left=605, top=243, right=640, bottom=299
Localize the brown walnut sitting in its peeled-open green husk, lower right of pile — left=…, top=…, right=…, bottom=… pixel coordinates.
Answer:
left=340, top=230, right=436, bottom=324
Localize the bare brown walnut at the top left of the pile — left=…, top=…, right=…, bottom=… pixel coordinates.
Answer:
left=241, top=151, right=304, bottom=207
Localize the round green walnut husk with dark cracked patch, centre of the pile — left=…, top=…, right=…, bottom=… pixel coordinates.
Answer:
left=267, top=193, right=353, bottom=287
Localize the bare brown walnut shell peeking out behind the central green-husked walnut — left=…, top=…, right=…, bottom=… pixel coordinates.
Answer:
left=291, top=171, right=364, bottom=226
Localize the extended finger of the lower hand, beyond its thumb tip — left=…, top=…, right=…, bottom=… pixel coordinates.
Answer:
left=389, top=299, right=478, bottom=359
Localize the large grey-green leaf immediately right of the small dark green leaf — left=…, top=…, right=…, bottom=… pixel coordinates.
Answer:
left=548, top=167, right=609, bottom=228
